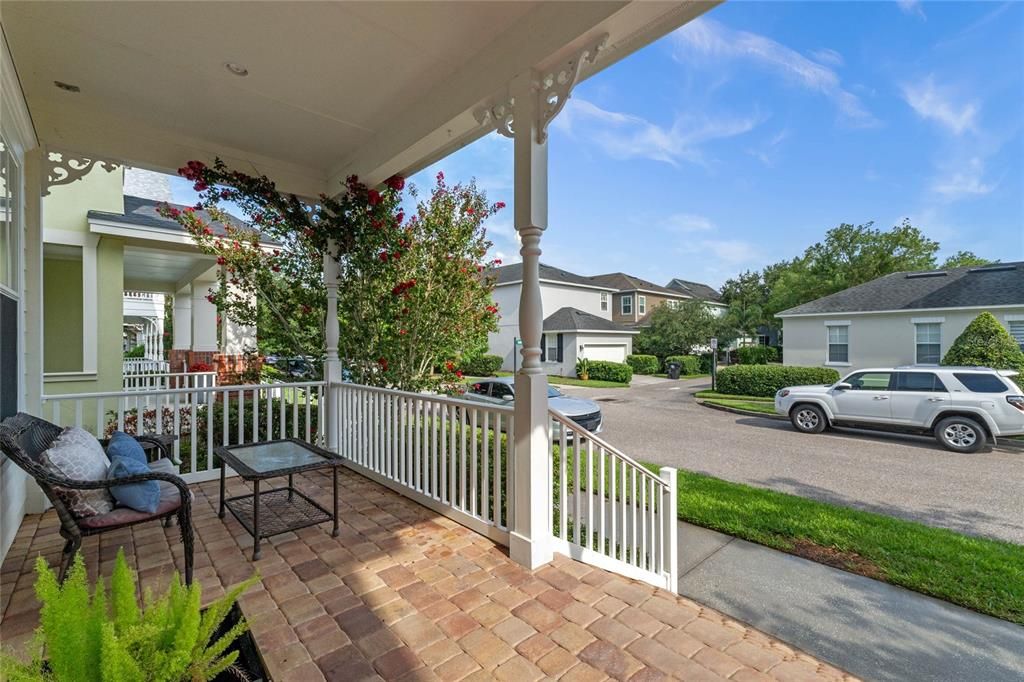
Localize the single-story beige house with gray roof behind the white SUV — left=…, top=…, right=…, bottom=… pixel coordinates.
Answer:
left=778, top=262, right=1024, bottom=373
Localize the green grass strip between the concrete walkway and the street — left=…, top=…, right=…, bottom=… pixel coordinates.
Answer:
left=647, top=465, right=1024, bottom=625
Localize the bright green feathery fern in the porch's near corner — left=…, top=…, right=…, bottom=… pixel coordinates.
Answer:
left=0, top=550, right=265, bottom=682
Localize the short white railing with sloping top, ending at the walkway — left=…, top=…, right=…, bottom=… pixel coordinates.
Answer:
left=549, top=410, right=679, bottom=592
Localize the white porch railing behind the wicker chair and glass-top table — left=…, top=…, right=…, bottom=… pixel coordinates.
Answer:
left=41, top=381, right=325, bottom=482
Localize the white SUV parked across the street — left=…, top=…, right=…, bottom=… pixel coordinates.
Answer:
left=775, top=367, right=1024, bottom=453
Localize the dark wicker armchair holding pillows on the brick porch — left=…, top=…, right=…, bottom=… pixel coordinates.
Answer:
left=0, top=413, right=194, bottom=585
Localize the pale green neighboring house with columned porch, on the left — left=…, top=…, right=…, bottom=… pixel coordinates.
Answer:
left=42, top=166, right=269, bottom=394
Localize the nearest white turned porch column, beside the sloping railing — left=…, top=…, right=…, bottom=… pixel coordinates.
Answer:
left=509, top=72, right=552, bottom=568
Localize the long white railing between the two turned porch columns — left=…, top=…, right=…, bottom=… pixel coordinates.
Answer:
left=331, top=383, right=514, bottom=545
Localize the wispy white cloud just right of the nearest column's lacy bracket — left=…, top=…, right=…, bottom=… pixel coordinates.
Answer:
left=553, top=97, right=761, bottom=166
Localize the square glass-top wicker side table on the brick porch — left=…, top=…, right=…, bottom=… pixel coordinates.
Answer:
left=214, top=438, right=341, bottom=561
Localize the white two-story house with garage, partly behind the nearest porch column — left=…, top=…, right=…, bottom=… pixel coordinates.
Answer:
left=487, top=263, right=636, bottom=376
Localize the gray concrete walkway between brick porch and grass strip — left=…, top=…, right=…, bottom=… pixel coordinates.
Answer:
left=679, top=522, right=1024, bottom=682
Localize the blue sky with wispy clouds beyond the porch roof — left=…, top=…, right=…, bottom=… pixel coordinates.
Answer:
left=412, top=2, right=1024, bottom=286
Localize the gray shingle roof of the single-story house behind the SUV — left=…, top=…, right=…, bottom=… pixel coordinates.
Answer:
left=779, top=262, right=1024, bottom=316
